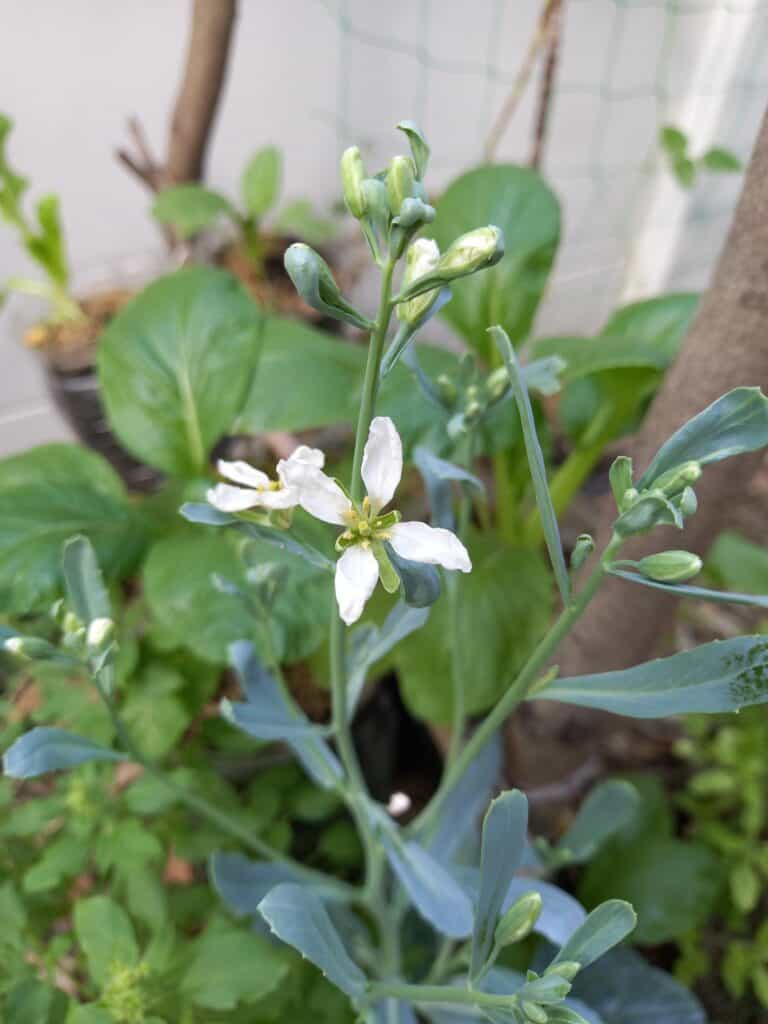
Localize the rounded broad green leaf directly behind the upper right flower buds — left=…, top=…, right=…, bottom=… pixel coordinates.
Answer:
left=430, top=165, right=560, bottom=360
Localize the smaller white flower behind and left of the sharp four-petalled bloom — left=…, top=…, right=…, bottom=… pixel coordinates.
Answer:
left=206, top=444, right=326, bottom=512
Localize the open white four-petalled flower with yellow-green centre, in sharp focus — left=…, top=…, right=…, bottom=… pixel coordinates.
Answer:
left=294, top=416, right=472, bottom=626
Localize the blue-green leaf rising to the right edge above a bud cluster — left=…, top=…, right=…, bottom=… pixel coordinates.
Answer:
left=637, top=387, right=768, bottom=489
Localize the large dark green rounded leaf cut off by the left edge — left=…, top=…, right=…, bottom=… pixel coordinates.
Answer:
left=0, top=444, right=146, bottom=613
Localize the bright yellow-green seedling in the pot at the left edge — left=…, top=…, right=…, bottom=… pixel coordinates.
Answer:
left=0, top=114, right=82, bottom=322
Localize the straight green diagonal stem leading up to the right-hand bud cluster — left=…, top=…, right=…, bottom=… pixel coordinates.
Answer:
left=412, top=537, right=622, bottom=829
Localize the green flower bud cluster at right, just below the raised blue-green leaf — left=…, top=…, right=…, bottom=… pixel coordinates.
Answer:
left=610, top=456, right=701, bottom=537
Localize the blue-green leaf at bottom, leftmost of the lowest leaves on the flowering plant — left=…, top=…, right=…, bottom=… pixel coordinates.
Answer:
left=259, top=884, right=367, bottom=999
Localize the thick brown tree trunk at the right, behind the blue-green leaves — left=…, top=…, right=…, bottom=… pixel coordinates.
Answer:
left=557, top=105, right=768, bottom=675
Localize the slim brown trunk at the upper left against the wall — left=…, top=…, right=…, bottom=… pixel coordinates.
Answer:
left=165, top=0, right=237, bottom=184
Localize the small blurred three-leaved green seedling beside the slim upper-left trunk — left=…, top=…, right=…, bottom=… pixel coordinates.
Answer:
left=152, top=145, right=334, bottom=271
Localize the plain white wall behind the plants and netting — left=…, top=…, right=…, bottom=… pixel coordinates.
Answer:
left=0, top=0, right=768, bottom=452
